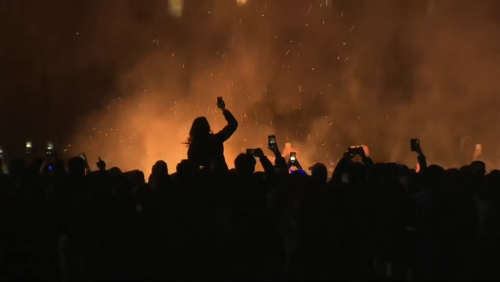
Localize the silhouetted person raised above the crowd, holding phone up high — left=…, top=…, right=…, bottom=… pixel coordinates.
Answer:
left=187, top=102, right=238, bottom=171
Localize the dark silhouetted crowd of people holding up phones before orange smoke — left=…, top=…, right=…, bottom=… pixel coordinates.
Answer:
left=0, top=104, right=500, bottom=281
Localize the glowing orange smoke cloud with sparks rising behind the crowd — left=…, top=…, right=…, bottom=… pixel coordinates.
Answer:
left=54, top=0, right=500, bottom=170
